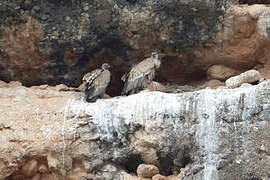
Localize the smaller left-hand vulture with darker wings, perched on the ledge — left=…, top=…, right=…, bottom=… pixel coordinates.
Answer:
left=83, top=63, right=110, bottom=102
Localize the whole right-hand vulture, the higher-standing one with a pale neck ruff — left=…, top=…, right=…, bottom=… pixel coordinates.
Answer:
left=121, top=52, right=160, bottom=95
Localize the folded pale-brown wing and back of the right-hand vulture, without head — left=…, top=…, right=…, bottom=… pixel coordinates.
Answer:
left=121, top=58, right=155, bottom=94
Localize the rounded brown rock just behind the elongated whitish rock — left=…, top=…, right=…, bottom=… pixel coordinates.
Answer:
left=207, top=65, right=239, bottom=81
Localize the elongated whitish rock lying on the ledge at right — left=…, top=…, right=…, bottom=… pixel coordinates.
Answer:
left=226, top=70, right=264, bottom=88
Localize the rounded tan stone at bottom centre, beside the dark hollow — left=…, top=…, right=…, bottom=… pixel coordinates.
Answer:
left=137, top=164, right=159, bottom=178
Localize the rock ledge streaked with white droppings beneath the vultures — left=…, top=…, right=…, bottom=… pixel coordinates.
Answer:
left=0, top=80, right=270, bottom=180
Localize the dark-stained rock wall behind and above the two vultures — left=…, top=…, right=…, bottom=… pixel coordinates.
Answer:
left=0, top=0, right=270, bottom=95
